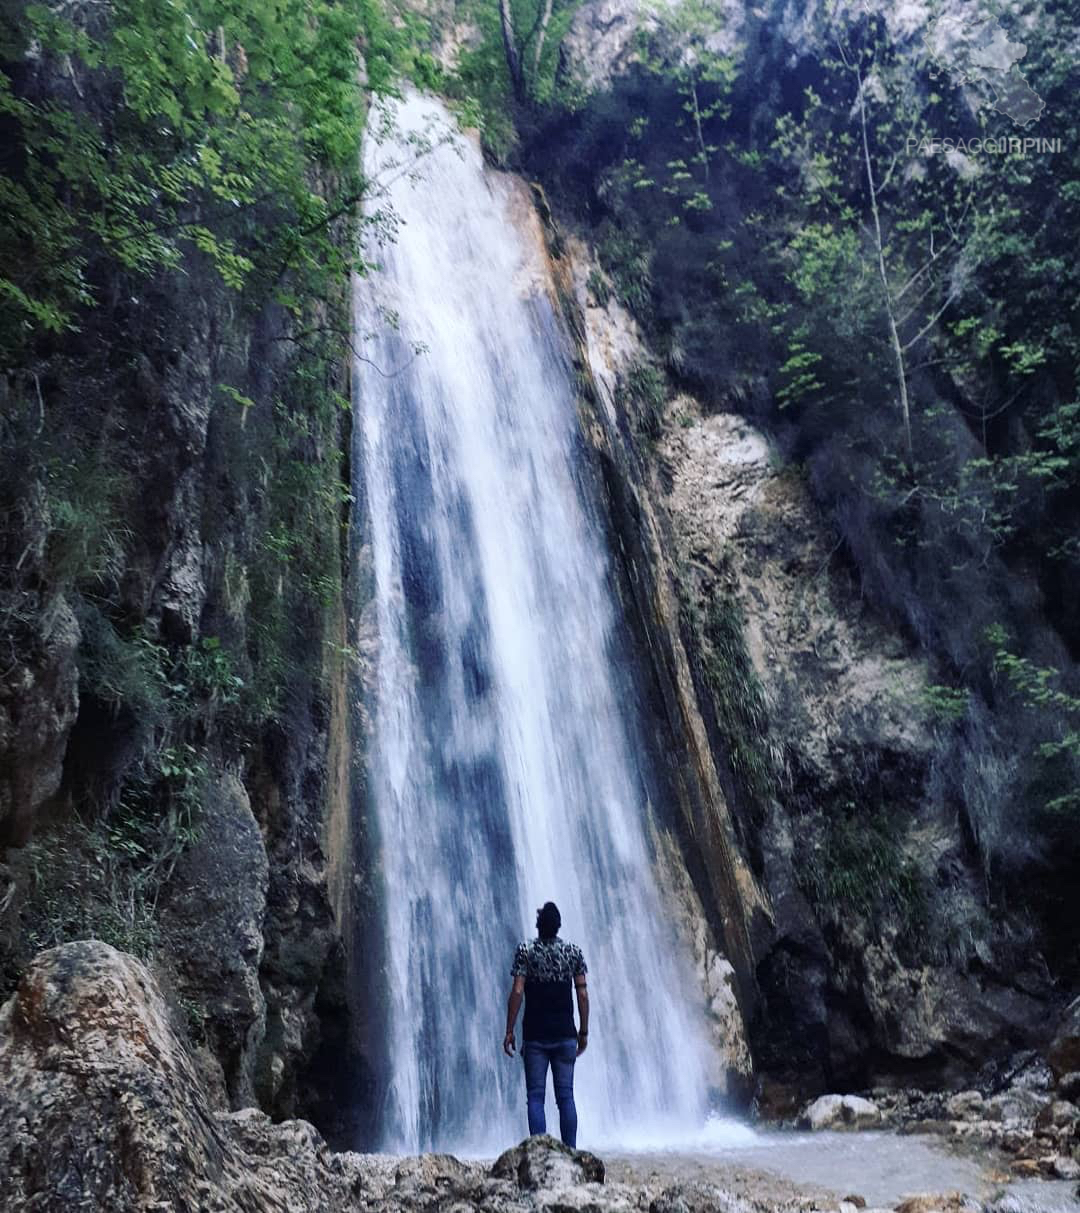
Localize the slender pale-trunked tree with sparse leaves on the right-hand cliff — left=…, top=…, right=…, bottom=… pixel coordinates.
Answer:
left=774, top=22, right=973, bottom=467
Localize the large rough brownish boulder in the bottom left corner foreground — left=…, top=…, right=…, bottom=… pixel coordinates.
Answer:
left=0, top=940, right=365, bottom=1213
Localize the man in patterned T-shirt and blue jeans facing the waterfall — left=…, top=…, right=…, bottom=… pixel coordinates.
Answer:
left=502, top=901, right=589, bottom=1146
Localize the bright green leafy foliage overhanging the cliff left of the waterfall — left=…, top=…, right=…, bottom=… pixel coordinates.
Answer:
left=0, top=0, right=396, bottom=361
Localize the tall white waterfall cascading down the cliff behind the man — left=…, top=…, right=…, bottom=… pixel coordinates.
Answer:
left=356, top=97, right=709, bottom=1151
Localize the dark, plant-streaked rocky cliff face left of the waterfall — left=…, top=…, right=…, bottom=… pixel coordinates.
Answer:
left=0, top=9, right=361, bottom=1130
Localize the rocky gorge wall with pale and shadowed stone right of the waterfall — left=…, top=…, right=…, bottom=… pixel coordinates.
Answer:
left=512, top=0, right=1075, bottom=1110
